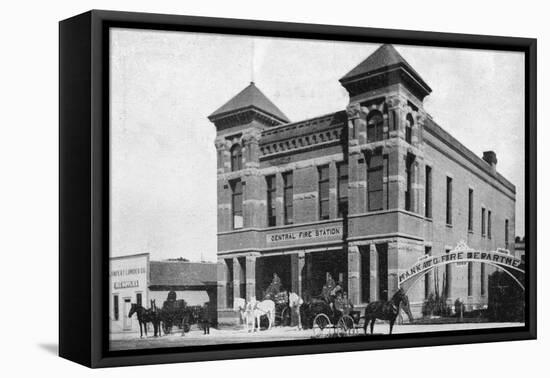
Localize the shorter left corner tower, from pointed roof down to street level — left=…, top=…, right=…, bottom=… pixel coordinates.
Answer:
left=208, top=82, right=289, bottom=316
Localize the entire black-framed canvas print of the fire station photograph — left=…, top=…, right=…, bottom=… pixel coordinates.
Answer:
left=59, top=11, right=536, bottom=367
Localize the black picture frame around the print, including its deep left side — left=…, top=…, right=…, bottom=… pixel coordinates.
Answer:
left=59, top=10, right=537, bottom=368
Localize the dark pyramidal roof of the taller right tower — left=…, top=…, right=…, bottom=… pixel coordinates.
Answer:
left=340, top=44, right=432, bottom=99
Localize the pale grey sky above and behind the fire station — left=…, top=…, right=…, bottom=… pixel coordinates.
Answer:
left=110, top=29, right=525, bottom=261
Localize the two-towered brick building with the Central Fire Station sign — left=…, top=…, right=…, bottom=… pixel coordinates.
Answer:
left=209, top=45, right=515, bottom=323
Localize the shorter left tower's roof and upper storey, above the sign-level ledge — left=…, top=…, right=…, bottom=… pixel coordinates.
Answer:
left=208, top=82, right=289, bottom=232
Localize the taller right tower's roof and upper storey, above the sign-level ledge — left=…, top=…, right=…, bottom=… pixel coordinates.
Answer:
left=340, top=44, right=432, bottom=213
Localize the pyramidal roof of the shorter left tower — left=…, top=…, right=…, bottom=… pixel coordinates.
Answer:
left=208, top=82, right=290, bottom=123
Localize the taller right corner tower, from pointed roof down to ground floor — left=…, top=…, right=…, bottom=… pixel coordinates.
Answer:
left=340, top=44, right=431, bottom=303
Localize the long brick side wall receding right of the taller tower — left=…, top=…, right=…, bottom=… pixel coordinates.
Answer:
left=423, top=124, right=515, bottom=308
